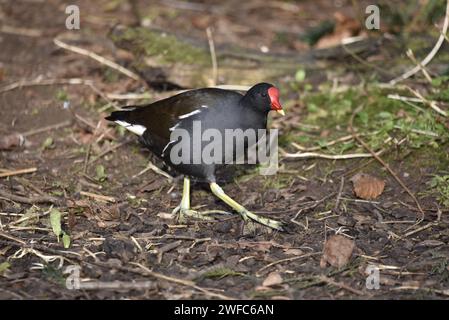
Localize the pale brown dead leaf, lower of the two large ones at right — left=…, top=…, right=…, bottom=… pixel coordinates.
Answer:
left=320, top=234, right=355, bottom=268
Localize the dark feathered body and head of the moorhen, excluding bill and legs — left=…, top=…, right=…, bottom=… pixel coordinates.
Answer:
left=106, top=83, right=273, bottom=182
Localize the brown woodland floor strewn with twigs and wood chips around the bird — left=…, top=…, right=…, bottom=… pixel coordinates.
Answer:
left=0, top=0, right=449, bottom=299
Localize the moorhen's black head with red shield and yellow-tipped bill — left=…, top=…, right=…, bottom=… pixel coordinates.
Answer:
left=243, top=83, right=284, bottom=115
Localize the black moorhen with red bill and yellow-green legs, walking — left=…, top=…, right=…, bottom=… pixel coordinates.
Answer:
left=106, top=83, right=284, bottom=230
